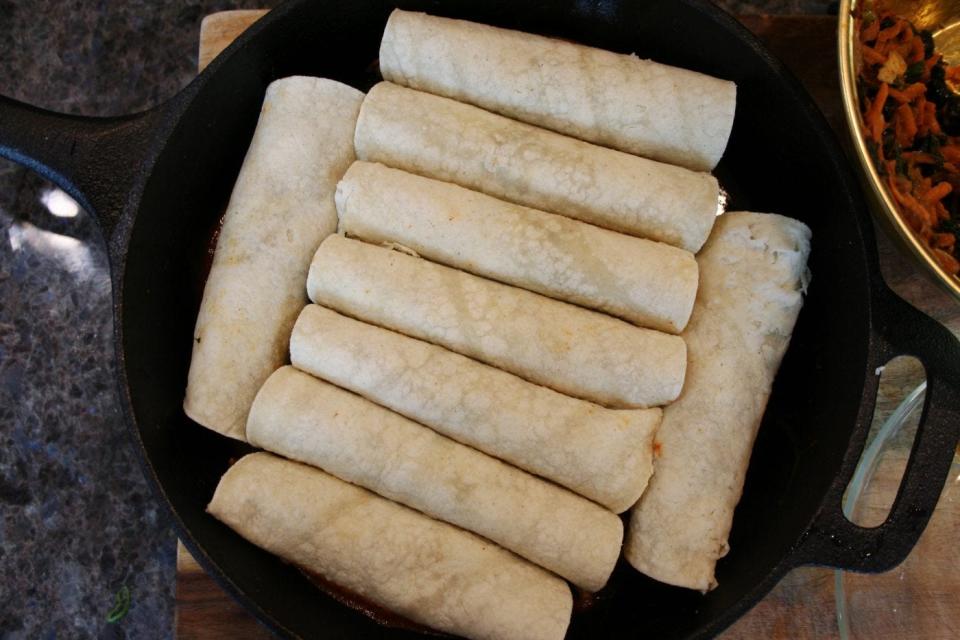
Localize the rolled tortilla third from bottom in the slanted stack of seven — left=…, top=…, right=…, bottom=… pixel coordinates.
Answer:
left=290, top=305, right=661, bottom=513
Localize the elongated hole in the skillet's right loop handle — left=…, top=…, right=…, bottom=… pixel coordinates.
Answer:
left=843, top=356, right=927, bottom=527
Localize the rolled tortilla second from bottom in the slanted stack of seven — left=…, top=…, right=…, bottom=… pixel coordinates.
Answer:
left=247, top=367, right=623, bottom=591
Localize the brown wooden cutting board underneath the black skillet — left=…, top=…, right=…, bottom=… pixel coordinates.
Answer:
left=175, top=11, right=960, bottom=640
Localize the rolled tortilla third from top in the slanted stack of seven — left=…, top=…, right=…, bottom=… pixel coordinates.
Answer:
left=336, top=162, right=697, bottom=333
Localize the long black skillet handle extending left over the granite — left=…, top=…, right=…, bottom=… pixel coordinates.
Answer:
left=0, top=96, right=160, bottom=254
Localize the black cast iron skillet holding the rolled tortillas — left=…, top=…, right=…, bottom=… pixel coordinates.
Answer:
left=0, top=0, right=960, bottom=638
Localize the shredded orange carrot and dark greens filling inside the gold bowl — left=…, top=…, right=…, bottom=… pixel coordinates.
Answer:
left=854, top=0, right=960, bottom=274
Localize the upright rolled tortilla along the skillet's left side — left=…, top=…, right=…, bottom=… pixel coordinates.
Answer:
left=183, top=76, right=363, bottom=440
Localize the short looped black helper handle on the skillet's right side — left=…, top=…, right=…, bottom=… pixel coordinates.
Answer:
left=799, top=284, right=960, bottom=572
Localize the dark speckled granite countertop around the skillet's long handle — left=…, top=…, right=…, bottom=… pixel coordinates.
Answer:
left=0, top=0, right=835, bottom=639
